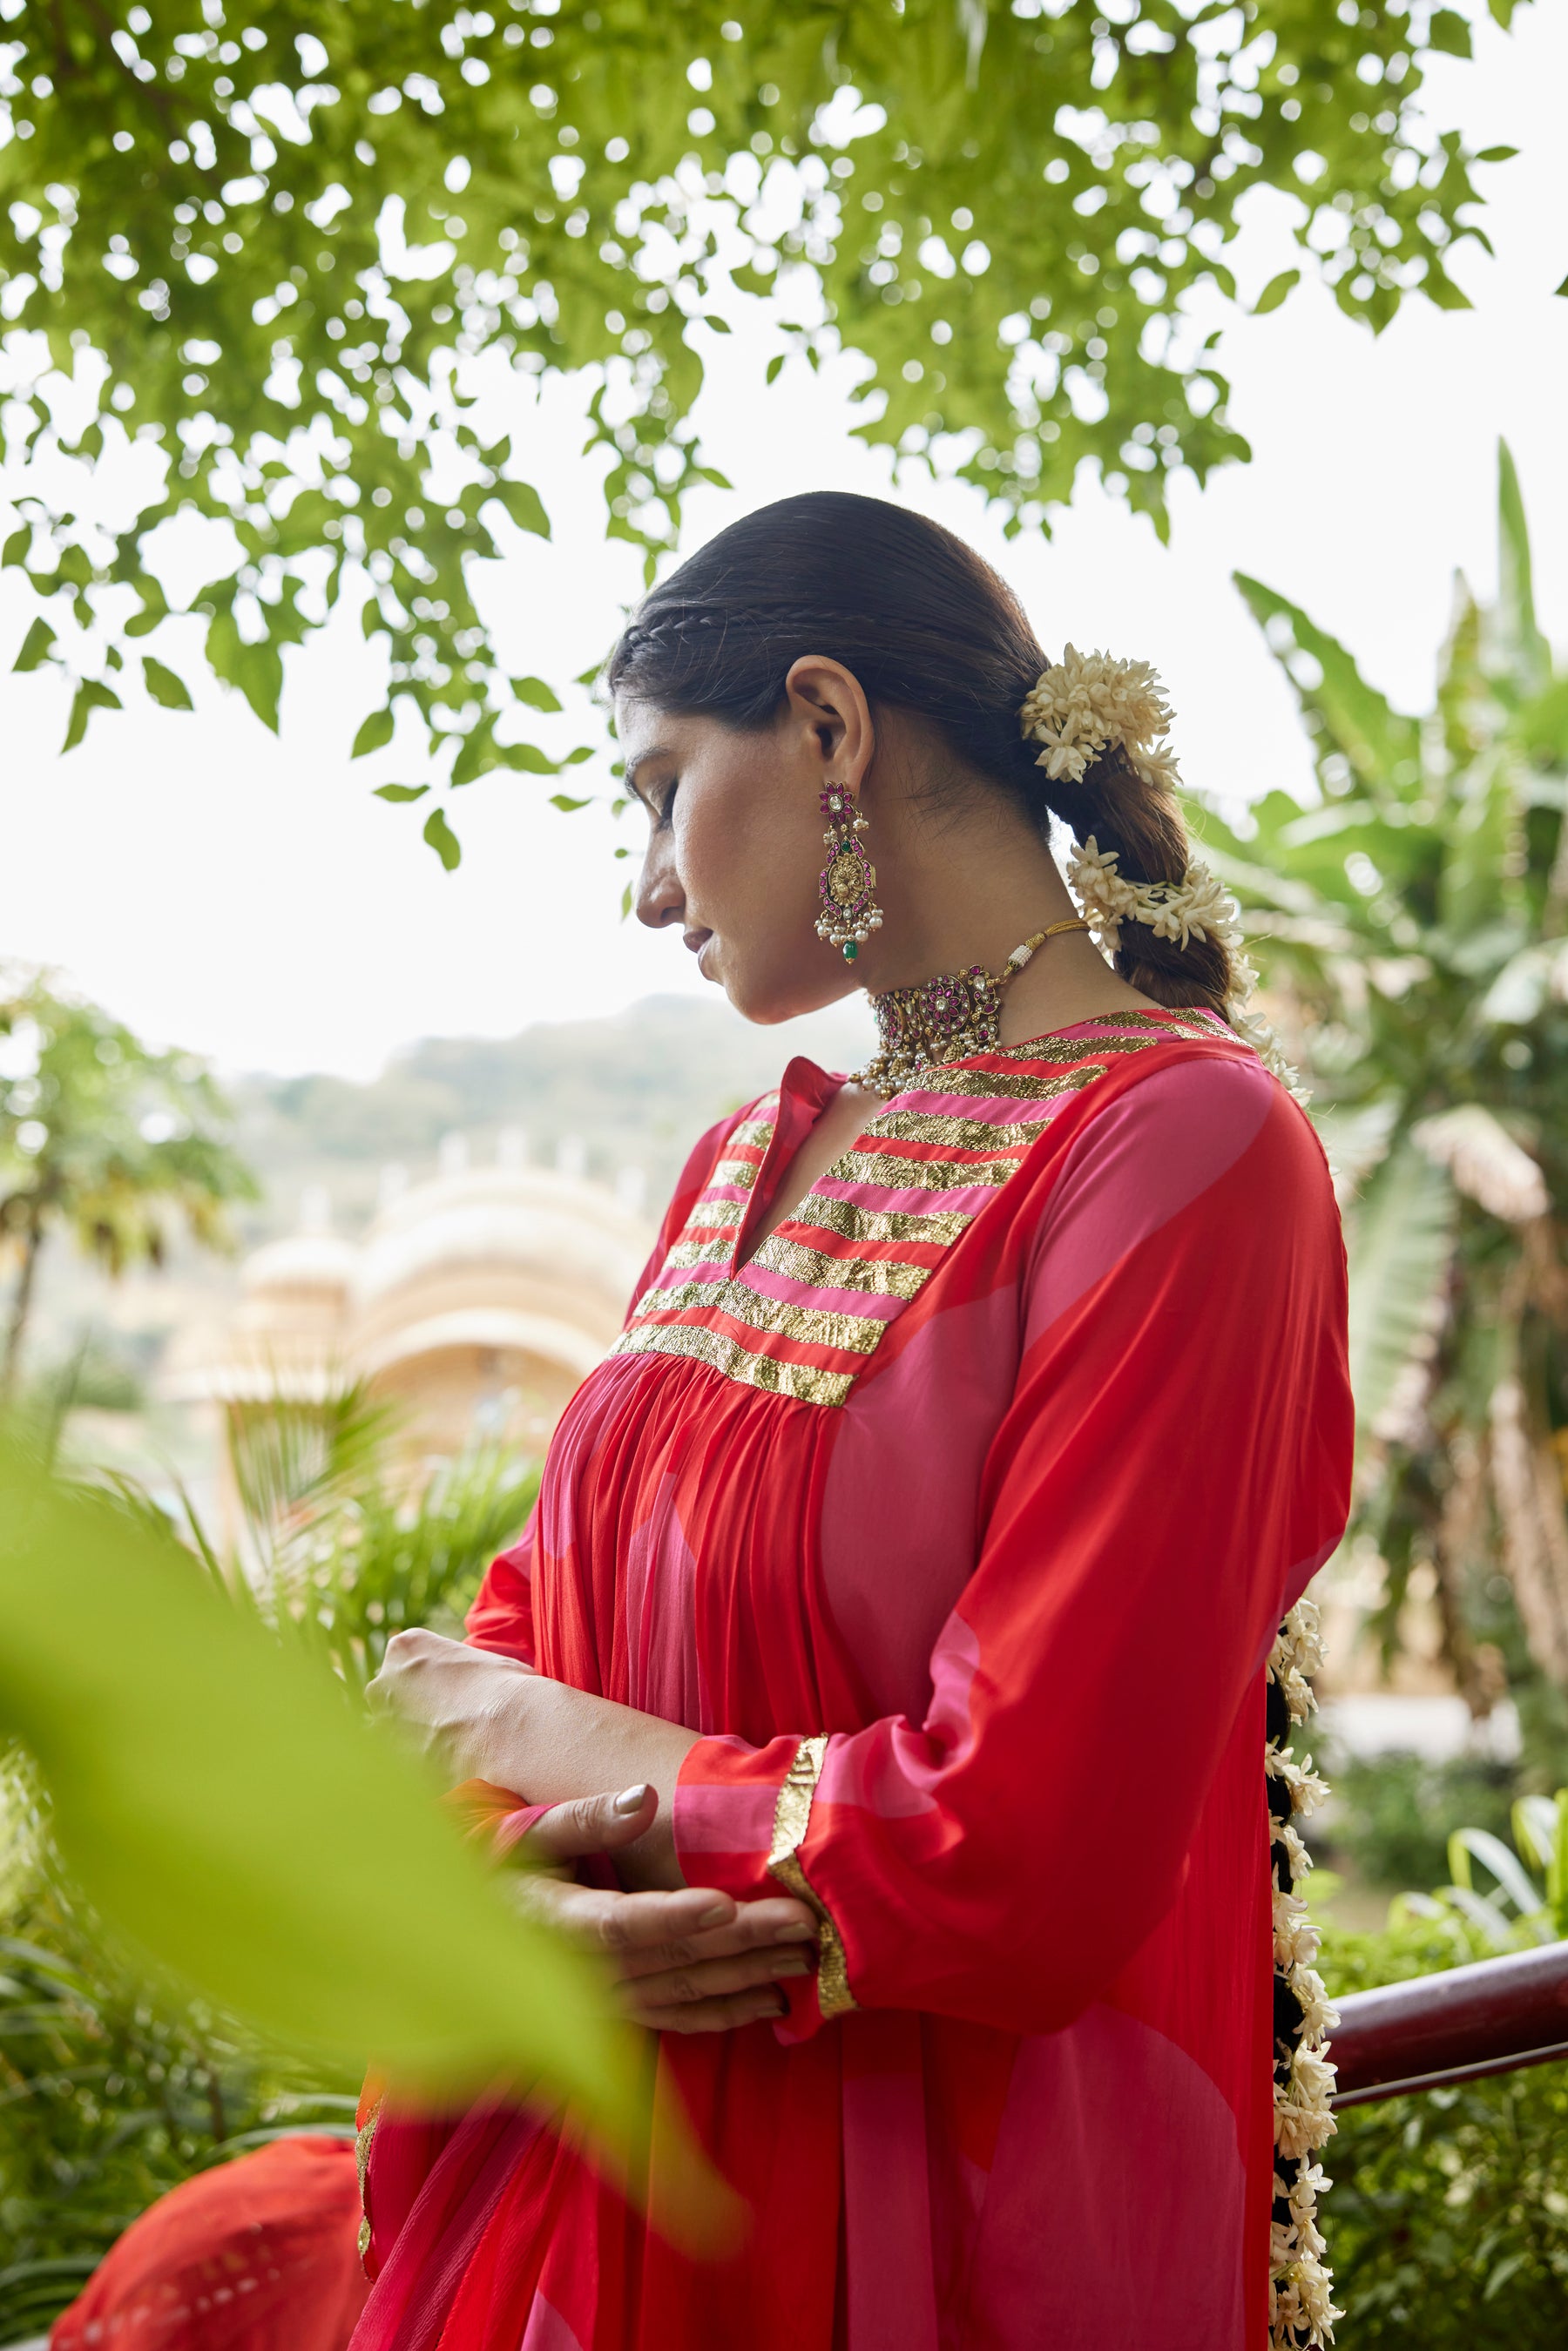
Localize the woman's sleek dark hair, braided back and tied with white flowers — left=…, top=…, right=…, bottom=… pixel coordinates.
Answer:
left=605, top=489, right=1232, bottom=1016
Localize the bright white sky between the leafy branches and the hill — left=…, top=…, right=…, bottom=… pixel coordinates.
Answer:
left=0, top=4, right=1568, bottom=1077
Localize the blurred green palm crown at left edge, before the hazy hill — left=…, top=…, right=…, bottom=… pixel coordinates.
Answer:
left=0, top=976, right=256, bottom=1396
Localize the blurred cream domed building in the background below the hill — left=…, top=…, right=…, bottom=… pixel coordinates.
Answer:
left=175, top=1138, right=653, bottom=1460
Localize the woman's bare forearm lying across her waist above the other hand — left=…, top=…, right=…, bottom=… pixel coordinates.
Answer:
left=468, top=1674, right=698, bottom=1888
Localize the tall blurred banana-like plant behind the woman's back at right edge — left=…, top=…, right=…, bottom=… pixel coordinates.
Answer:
left=1197, top=447, right=1568, bottom=1714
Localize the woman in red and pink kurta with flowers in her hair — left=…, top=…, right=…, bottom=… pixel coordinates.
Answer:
left=355, top=496, right=1349, bottom=2351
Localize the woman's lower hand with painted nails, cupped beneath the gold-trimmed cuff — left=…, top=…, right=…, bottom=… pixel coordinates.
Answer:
left=512, top=1787, right=815, bottom=2034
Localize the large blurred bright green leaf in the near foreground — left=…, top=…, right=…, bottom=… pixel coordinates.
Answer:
left=0, top=1446, right=642, bottom=2149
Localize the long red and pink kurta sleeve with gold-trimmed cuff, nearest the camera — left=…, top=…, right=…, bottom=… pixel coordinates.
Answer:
left=675, top=1058, right=1349, bottom=2034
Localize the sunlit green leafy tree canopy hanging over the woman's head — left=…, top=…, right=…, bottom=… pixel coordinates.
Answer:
left=0, top=0, right=1511, bottom=863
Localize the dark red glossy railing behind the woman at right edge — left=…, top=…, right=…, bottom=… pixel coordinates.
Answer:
left=1330, top=1942, right=1568, bottom=2106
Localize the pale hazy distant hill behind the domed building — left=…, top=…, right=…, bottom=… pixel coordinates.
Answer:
left=230, top=996, right=870, bottom=1239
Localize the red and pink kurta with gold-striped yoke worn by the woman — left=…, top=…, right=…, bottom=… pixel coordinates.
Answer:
left=355, top=1013, right=1352, bottom=2351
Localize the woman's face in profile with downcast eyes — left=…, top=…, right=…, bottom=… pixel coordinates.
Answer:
left=616, top=663, right=872, bottom=1023
